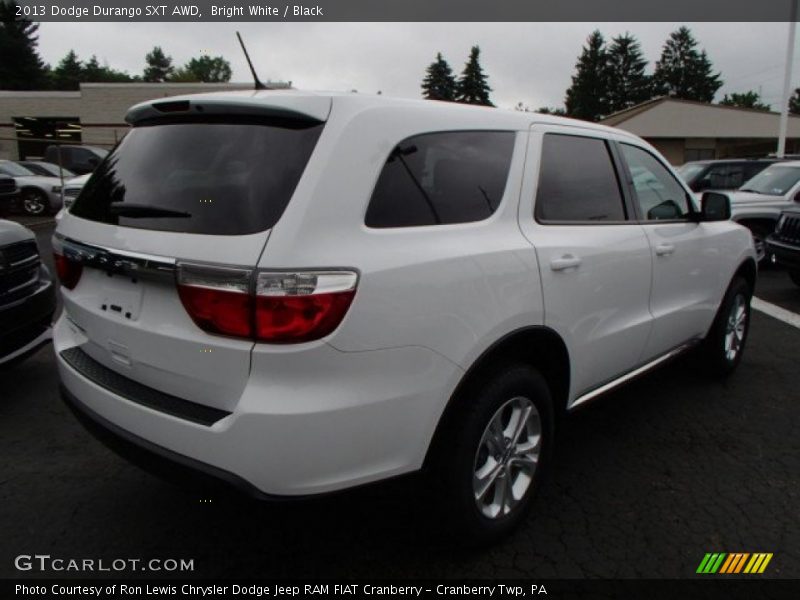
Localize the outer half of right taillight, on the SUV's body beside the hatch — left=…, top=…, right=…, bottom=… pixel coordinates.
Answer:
left=255, top=271, right=358, bottom=344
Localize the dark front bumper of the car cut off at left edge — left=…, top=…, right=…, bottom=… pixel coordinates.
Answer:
left=0, top=269, right=56, bottom=365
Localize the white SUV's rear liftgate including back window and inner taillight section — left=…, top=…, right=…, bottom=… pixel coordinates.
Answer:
left=54, top=96, right=330, bottom=411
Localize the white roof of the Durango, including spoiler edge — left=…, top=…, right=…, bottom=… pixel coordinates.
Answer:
left=126, top=90, right=636, bottom=138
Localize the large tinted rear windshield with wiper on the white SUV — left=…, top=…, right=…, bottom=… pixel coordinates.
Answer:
left=70, top=120, right=323, bottom=235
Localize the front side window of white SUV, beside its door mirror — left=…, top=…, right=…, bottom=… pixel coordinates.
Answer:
left=620, top=144, right=691, bottom=221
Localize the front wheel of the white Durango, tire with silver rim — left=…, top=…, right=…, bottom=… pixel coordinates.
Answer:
left=702, top=277, right=753, bottom=377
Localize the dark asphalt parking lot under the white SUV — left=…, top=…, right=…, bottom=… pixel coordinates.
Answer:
left=0, top=224, right=800, bottom=578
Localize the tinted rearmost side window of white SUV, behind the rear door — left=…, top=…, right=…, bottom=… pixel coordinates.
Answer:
left=365, top=131, right=515, bottom=228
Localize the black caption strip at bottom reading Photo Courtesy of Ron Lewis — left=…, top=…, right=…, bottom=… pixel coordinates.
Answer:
left=0, top=576, right=800, bottom=600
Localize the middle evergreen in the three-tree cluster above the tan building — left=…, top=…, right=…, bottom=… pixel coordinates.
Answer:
left=607, top=33, right=650, bottom=113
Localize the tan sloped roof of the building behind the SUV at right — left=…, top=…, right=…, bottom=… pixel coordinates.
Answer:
left=600, top=97, right=800, bottom=138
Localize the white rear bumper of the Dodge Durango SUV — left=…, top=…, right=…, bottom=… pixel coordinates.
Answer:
left=54, top=316, right=462, bottom=498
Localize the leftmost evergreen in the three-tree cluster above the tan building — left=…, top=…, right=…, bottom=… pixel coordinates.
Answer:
left=564, top=30, right=609, bottom=121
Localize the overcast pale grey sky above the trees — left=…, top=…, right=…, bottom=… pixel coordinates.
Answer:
left=34, top=22, right=800, bottom=110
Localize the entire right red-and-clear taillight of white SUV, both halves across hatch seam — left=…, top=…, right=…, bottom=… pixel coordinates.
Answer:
left=178, top=263, right=358, bottom=344
